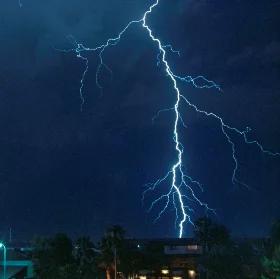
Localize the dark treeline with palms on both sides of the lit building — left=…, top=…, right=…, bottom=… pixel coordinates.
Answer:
left=32, top=220, right=280, bottom=279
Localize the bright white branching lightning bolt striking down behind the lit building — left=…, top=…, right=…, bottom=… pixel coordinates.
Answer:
left=61, top=0, right=280, bottom=238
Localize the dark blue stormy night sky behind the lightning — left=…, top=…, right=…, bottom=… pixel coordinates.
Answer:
left=0, top=0, right=280, bottom=239
